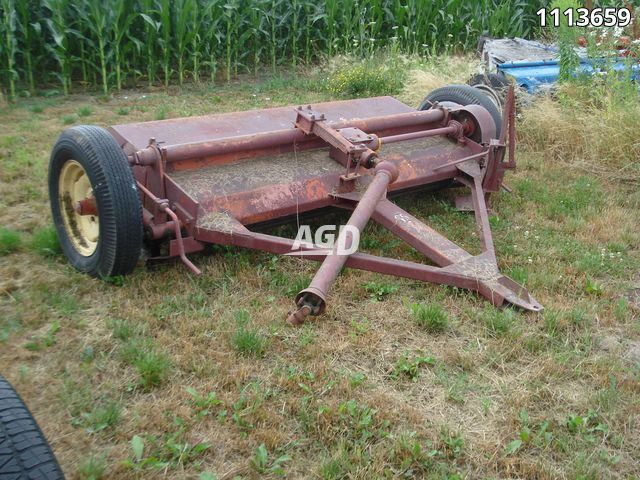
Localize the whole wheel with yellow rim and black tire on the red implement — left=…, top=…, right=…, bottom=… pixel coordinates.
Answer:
left=49, top=125, right=143, bottom=277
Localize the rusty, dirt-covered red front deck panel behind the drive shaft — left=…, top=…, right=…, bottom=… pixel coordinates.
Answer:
left=168, top=138, right=470, bottom=225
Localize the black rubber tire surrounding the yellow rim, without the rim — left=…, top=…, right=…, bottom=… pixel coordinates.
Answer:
left=49, top=125, right=143, bottom=277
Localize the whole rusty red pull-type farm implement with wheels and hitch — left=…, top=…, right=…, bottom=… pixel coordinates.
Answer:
left=49, top=85, right=542, bottom=323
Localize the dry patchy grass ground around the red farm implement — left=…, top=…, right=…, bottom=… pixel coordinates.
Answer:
left=0, top=59, right=640, bottom=479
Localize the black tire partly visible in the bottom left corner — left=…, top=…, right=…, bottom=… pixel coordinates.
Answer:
left=0, top=375, right=64, bottom=480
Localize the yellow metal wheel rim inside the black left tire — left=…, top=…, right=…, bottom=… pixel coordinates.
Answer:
left=58, top=160, right=100, bottom=257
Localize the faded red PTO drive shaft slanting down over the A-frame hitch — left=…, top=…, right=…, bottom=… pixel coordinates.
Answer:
left=287, top=161, right=399, bottom=325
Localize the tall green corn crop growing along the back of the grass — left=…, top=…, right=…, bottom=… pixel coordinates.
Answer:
left=0, top=0, right=542, bottom=99
